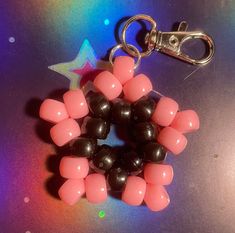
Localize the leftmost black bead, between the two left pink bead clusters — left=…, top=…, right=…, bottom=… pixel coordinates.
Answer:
left=72, top=138, right=97, bottom=157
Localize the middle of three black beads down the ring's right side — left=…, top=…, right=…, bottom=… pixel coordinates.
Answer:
left=132, top=122, right=157, bottom=143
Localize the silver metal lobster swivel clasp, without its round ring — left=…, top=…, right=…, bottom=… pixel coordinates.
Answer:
left=145, top=21, right=215, bottom=65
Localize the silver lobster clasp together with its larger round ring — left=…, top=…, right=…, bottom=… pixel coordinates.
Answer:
left=122, top=15, right=215, bottom=65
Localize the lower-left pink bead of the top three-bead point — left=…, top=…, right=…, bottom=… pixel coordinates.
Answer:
left=93, top=71, right=122, bottom=100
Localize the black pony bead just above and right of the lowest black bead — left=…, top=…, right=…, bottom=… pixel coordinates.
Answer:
left=122, top=151, right=144, bottom=173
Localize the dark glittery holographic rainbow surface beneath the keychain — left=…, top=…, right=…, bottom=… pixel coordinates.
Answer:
left=0, top=0, right=235, bottom=233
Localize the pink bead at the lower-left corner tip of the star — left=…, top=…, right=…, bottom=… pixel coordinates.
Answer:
left=58, top=179, right=85, bottom=205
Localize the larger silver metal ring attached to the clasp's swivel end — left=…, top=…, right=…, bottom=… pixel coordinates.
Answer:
left=122, top=14, right=157, bottom=57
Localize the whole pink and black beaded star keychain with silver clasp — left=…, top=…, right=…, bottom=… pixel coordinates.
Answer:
left=40, top=15, right=214, bottom=211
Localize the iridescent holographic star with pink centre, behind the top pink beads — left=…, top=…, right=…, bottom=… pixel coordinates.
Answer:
left=48, top=39, right=110, bottom=89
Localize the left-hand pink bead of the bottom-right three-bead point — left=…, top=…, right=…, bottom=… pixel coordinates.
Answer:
left=122, top=176, right=146, bottom=206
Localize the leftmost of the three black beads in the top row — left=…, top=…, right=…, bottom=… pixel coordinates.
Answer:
left=86, top=92, right=111, bottom=119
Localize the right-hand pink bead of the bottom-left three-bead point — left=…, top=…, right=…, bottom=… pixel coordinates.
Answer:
left=85, top=173, right=108, bottom=204
